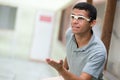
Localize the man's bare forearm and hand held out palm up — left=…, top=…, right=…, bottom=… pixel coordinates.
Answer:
left=46, top=59, right=92, bottom=80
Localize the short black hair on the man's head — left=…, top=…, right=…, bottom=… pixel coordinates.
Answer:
left=72, top=2, right=97, bottom=21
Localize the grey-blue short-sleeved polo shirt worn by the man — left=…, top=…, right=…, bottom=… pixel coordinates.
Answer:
left=66, top=29, right=107, bottom=80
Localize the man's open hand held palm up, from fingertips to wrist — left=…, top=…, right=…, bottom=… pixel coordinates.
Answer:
left=46, top=58, right=64, bottom=72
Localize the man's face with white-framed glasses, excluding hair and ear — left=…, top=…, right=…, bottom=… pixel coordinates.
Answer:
left=71, top=9, right=91, bottom=34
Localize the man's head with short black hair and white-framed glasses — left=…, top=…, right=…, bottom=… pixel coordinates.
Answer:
left=71, top=2, right=97, bottom=34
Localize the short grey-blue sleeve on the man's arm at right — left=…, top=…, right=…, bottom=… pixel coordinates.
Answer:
left=82, top=51, right=106, bottom=78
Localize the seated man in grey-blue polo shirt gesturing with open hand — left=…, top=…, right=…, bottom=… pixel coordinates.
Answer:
left=46, top=2, right=106, bottom=80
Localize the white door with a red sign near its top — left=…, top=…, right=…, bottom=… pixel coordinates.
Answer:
left=30, top=10, right=54, bottom=60
